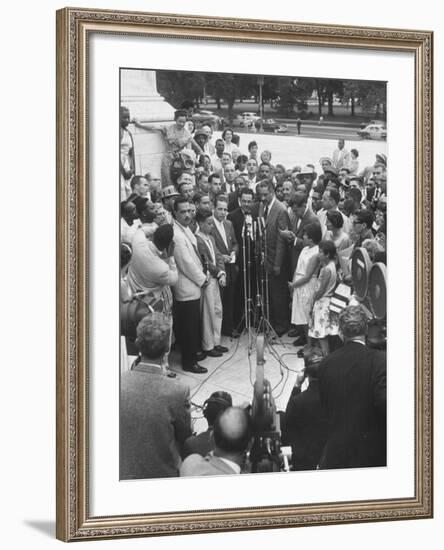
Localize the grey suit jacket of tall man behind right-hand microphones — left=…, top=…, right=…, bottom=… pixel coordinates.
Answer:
left=258, top=199, right=289, bottom=273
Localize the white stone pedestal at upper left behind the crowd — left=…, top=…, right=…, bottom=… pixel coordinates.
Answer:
left=120, top=69, right=174, bottom=178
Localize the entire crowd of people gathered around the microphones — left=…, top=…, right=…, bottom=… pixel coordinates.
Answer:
left=120, top=107, right=387, bottom=479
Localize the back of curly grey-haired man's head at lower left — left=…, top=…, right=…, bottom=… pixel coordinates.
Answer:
left=136, top=311, right=171, bottom=360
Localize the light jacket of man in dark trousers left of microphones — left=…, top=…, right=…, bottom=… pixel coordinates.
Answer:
left=173, top=222, right=205, bottom=302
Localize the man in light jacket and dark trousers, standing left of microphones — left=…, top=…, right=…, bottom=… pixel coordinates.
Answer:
left=173, top=197, right=208, bottom=374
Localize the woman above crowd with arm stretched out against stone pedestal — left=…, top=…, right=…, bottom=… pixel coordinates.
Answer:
left=134, top=110, right=203, bottom=187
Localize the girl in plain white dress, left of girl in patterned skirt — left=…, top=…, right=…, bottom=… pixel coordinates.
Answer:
left=289, top=223, right=322, bottom=350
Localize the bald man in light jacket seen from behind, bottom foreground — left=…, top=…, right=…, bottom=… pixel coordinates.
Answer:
left=180, top=407, right=251, bottom=477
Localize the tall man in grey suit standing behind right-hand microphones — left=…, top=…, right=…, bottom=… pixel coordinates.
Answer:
left=256, top=180, right=290, bottom=336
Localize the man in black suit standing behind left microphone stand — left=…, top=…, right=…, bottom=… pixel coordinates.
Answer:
left=228, top=187, right=256, bottom=335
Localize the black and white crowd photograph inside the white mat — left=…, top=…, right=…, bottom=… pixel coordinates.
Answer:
left=119, top=67, right=389, bottom=481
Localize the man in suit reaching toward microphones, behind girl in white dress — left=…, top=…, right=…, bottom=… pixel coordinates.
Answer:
left=280, top=191, right=321, bottom=281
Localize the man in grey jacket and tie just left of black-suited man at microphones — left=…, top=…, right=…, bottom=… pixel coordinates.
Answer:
left=211, top=195, right=239, bottom=336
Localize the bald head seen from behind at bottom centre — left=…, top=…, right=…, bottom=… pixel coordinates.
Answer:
left=213, top=407, right=251, bottom=456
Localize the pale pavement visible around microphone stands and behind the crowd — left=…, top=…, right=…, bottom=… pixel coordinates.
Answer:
left=126, top=132, right=387, bottom=432
